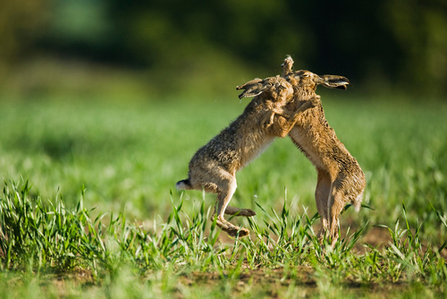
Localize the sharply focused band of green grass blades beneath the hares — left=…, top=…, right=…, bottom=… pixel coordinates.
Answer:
left=0, top=182, right=447, bottom=297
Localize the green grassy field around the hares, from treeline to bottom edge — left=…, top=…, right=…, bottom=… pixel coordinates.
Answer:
left=0, top=92, right=447, bottom=298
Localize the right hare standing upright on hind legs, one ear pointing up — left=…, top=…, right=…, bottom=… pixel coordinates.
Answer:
left=283, top=57, right=366, bottom=247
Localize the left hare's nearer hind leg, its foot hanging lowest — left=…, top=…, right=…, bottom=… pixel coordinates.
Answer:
left=216, top=175, right=249, bottom=237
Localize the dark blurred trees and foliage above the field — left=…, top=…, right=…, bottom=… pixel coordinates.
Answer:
left=0, top=0, right=447, bottom=99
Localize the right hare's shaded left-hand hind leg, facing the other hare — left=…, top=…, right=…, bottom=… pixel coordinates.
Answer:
left=315, top=169, right=331, bottom=243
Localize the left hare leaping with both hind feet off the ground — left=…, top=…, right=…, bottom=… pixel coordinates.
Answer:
left=176, top=76, right=319, bottom=237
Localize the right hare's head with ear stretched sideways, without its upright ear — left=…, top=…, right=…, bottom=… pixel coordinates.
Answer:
left=288, top=70, right=349, bottom=90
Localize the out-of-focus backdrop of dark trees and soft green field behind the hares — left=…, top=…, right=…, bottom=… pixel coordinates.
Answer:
left=0, top=0, right=447, bottom=245
